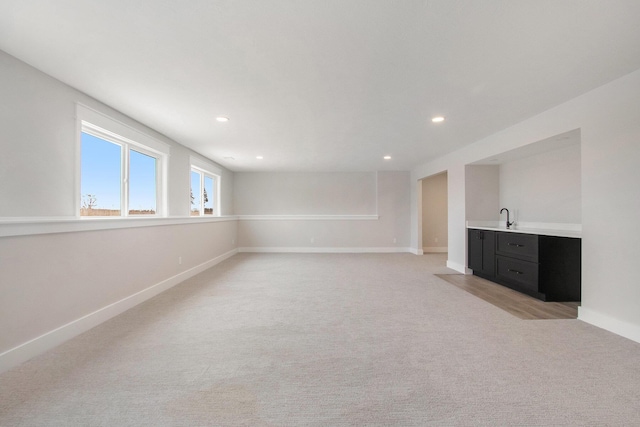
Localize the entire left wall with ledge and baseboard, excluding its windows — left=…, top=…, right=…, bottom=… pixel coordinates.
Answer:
left=0, top=52, right=237, bottom=371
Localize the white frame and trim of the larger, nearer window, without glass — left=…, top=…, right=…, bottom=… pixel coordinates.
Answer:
left=75, top=103, right=171, bottom=220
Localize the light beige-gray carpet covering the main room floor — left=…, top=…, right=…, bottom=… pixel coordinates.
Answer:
left=0, top=254, right=640, bottom=426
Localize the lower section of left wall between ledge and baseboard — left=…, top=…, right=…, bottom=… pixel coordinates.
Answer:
left=0, top=221, right=237, bottom=362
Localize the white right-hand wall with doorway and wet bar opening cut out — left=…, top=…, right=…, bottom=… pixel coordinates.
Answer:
left=411, top=70, right=640, bottom=341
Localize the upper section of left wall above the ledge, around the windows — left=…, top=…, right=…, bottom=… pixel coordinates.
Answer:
left=0, top=51, right=233, bottom=218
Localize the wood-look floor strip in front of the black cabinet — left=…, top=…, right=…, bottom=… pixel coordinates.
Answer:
left=436, top=274, right=580, bottom=320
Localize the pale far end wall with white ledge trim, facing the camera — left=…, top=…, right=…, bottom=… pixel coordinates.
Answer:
left=234, top=172, right=410, bottom=252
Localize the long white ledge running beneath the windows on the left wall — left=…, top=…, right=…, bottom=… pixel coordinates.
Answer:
left=0, top=215, right=238, bottom=237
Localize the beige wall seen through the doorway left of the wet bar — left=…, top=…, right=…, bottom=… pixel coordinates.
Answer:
left=422, top=173, right=449, bottom=252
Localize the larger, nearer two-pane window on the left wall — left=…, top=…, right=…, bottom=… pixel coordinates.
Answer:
left=78, top=105, right=169, bottom=217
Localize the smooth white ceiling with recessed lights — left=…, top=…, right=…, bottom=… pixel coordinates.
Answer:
left=0, top=0, right=640, bottom=171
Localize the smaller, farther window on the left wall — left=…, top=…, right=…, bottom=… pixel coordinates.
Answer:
left=189, top=157, right=220, bottom=216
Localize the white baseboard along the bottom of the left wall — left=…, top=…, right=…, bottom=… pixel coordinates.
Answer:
left=0, top=249, right=238, bottom=373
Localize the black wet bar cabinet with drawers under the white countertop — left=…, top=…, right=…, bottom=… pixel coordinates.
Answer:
left=468, top=229, right=582, bottom=301
